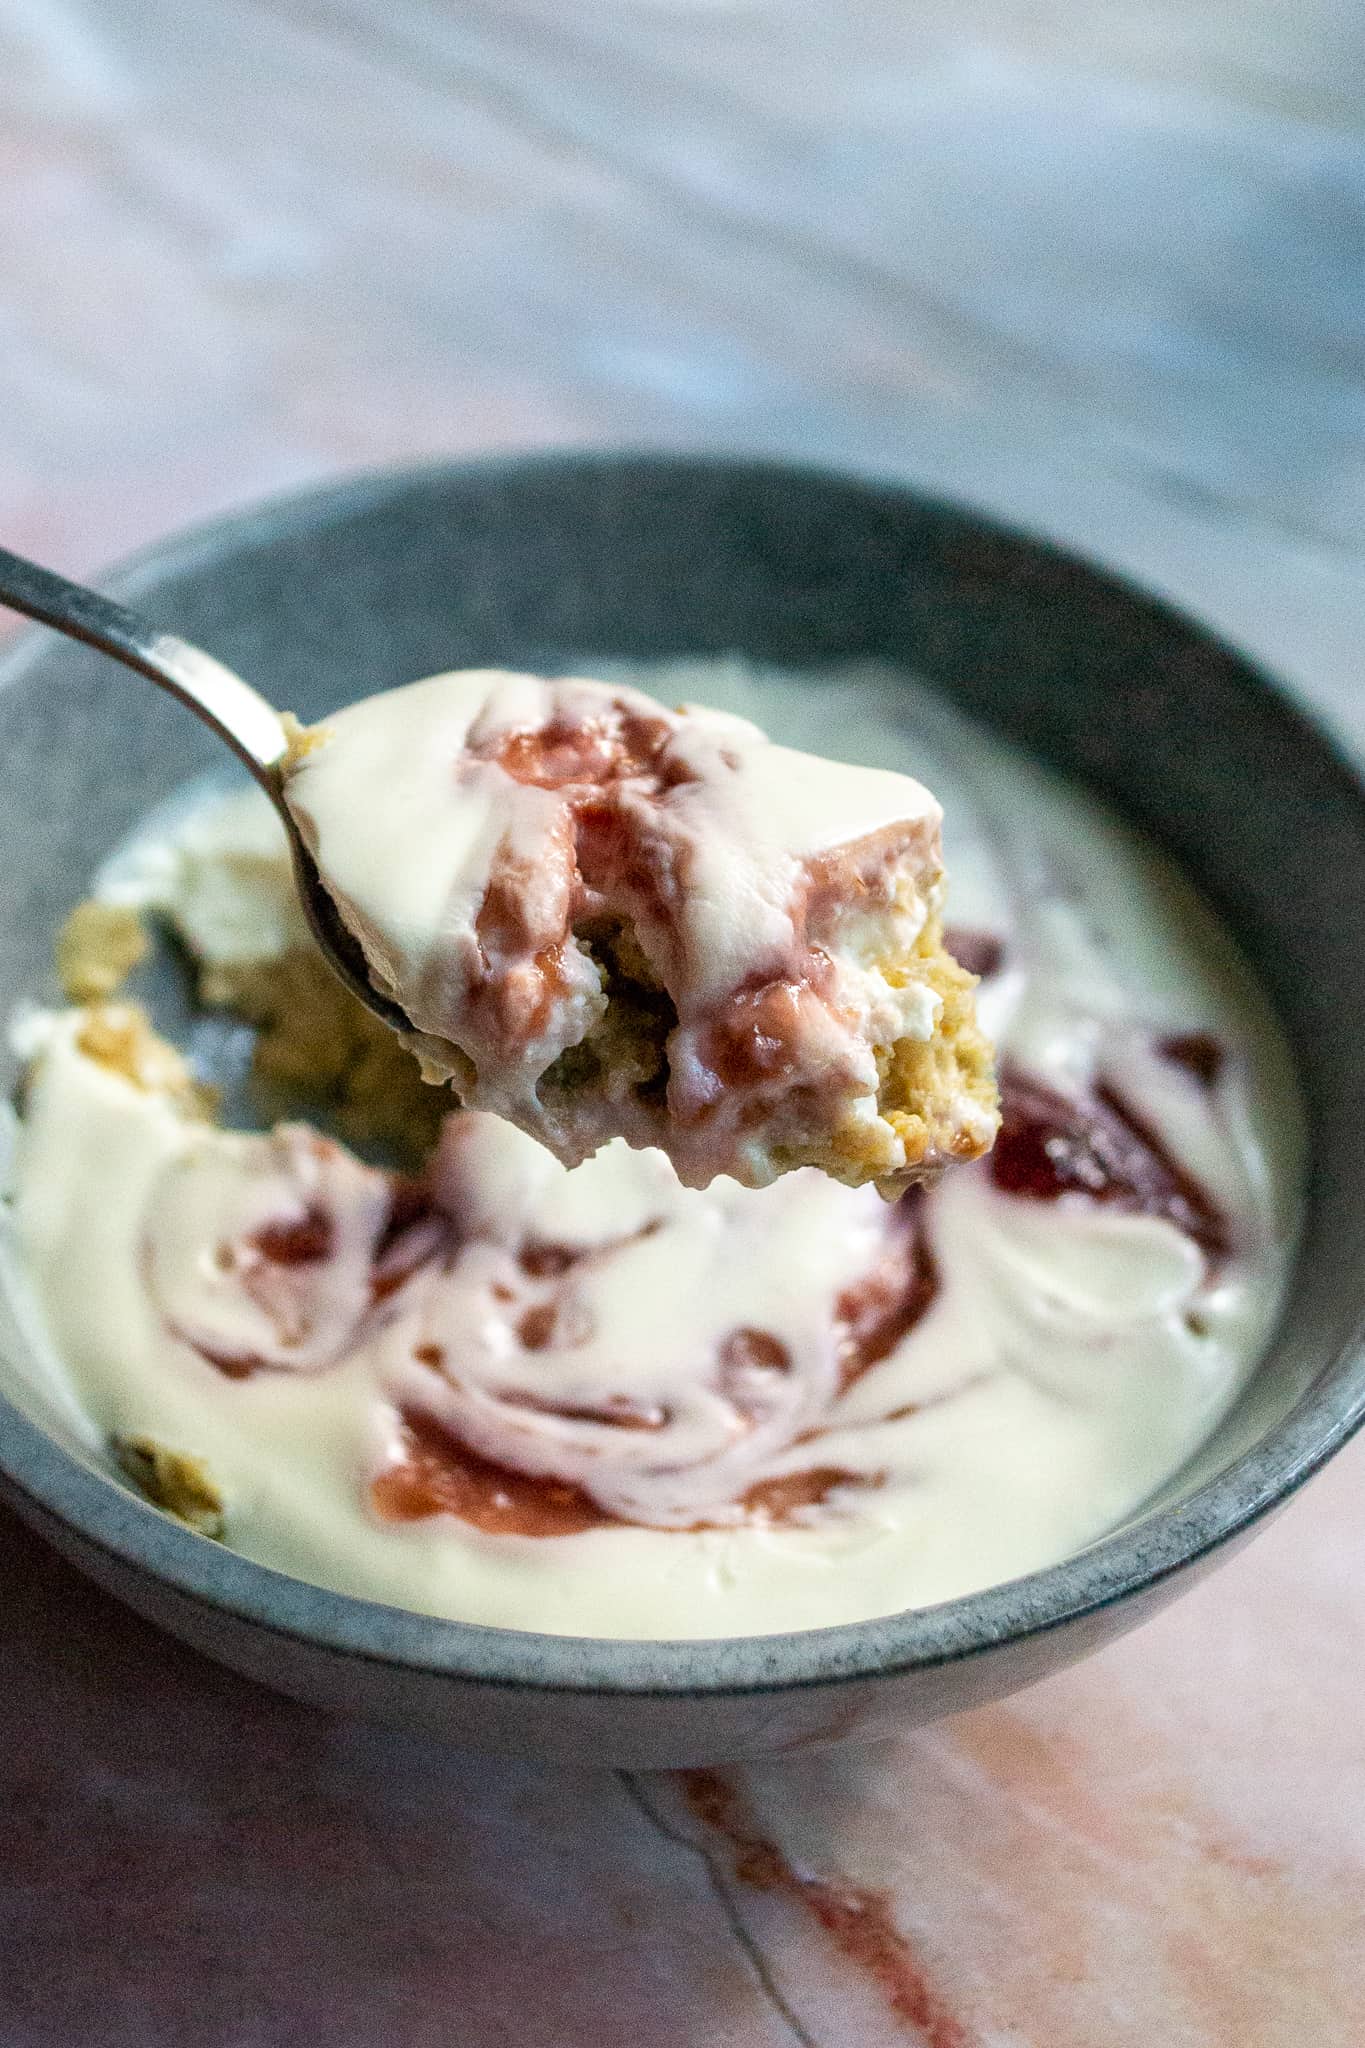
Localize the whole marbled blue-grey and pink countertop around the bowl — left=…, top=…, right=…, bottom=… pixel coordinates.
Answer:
left=0, top=0, right=1365, bottom=2048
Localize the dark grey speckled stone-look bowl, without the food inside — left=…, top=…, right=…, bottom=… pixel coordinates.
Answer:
left=0, top=455, right=1365, bottom=1765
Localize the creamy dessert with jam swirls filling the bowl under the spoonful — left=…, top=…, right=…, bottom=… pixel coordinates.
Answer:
left=8, top=662, right=1300, bottom=1636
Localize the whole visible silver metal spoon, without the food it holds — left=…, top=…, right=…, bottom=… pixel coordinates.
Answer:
left=0, top=547, right=411, bottom=1030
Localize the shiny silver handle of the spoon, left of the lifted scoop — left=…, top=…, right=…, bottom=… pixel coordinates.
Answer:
left=0, top=547, right=287, bottom=795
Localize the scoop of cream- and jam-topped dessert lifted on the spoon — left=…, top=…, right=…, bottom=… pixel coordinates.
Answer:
left=287, top=672, right=995, bottom=1188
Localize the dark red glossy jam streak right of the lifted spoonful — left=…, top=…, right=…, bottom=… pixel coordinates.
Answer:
left=990, top=1069, right=1230, bottom=1257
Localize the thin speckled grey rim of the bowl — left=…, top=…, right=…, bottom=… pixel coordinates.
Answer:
left=0, top=446, right=1365, bottom=1700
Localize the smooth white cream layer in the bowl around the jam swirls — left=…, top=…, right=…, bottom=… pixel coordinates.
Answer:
left=0, top=666, right=1297, bottom=1636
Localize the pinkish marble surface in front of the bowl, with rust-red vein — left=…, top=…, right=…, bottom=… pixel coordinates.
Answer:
left=0, top=1454, right=1365, bottom=2048
